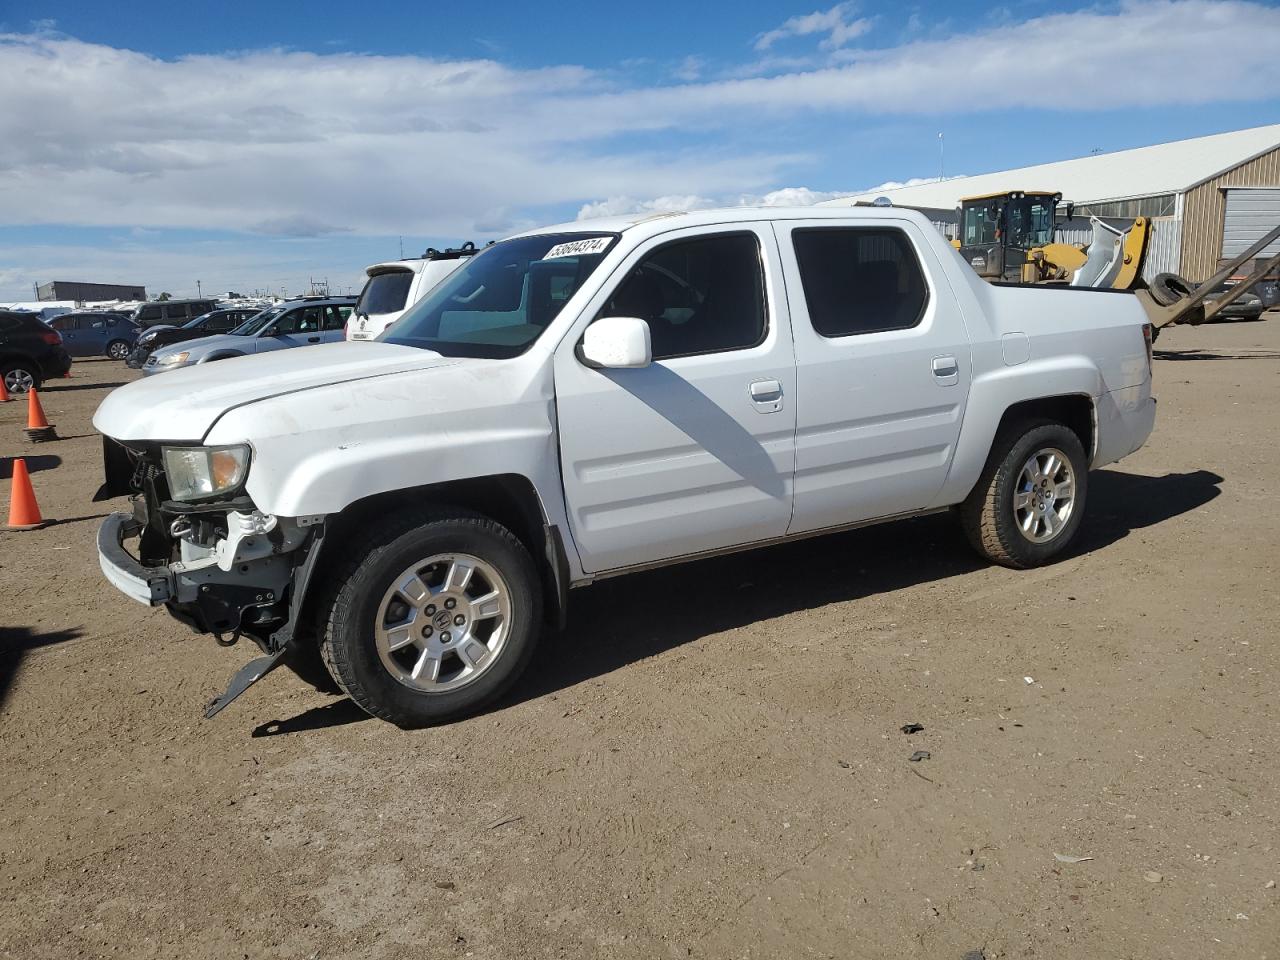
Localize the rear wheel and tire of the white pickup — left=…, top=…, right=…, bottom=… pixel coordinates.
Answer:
left=960, top=420, right=1089, bottom=570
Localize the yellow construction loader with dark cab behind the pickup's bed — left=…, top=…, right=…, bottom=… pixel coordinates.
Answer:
left=952, top=191, right=1151, bottom=291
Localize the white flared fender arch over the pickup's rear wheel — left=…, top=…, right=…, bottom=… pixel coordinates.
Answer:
left=931, top=355, right=1105, bottom=507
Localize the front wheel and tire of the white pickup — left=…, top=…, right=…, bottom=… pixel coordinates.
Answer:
left=320, top=509, right=543, bottom=728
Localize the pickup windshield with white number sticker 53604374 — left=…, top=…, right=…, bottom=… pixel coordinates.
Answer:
left=378, top=233, right=617, bottom=358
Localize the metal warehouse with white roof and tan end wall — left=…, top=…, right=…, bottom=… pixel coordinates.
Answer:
left=823, top=124, right=1280, bottom=280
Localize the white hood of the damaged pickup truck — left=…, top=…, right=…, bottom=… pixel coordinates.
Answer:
left=93, top=343, right=458, bottom=443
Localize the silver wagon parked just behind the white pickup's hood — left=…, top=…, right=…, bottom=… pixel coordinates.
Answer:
left=142, top=297, right=356, bottom=376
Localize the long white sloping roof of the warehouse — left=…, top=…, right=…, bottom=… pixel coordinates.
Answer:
left=819, top=124, right=1280, bottom=210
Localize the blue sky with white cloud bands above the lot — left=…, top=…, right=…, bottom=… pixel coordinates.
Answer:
left=0, top=0, right=1280, bottom=301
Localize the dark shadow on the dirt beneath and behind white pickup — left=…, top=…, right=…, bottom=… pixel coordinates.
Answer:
left=497, top=470, right=1222, bottom=709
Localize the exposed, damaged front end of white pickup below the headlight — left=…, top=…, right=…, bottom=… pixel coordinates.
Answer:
left=97, top=495, right=324, bottom=718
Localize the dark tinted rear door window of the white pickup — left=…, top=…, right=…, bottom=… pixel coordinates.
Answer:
left=791, top=227, right=928, bottom=337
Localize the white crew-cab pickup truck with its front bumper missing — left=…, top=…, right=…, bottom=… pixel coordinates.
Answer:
left=93, top=207, right=1155, bottom=726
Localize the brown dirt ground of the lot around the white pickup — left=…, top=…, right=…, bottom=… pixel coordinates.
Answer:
left=0, top=315, right=1280, bottom=960
